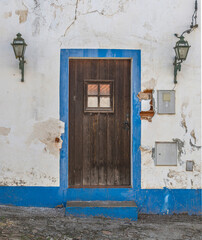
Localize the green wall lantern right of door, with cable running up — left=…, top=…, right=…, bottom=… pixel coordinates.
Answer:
left=173, top=0, right=198, bottom=84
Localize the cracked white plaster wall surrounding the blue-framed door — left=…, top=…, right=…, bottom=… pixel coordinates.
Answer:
left=0, top=0, right=201, bottom=188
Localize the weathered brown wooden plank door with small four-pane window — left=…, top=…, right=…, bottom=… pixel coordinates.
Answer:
left=68, top=59, right=131, bottom=188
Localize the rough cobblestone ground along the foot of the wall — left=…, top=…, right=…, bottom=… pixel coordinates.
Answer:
left=0, top=206, right=202, bottom=240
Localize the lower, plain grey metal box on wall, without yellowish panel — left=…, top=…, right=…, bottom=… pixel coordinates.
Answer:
left=155, top=142, right=177, bottom=166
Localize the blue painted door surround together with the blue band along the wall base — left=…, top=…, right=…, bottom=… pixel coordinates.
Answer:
left=0, top=49, right=201, bottom=214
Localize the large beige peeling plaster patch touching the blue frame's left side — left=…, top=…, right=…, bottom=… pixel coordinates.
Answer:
left=27, top=118, right=64, bottom=156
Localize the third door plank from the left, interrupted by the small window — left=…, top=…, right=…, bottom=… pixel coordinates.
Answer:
left=81, top=60, right=92, bottom=186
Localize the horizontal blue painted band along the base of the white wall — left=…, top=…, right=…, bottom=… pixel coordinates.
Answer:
left=0, top=187, right=202, bottom=215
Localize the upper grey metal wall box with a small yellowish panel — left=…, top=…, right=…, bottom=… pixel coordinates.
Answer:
left=157, top=90, right=175, bottom=114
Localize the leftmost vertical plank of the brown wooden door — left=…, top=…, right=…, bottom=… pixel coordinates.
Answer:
left=68, top=60, right=77, bottom=185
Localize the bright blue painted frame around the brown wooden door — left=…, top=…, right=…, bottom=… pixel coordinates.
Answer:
left=60, top=49, right=141, bottom=201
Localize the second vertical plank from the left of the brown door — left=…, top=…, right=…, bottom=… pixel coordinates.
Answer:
left=74, top=60, right=84, bottom=186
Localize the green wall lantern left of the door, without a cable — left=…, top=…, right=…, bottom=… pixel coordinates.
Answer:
left=11, top=33, right=27, bottom=82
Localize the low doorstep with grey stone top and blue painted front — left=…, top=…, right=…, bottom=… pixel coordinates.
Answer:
left=65, top=201, right=138, bottom=221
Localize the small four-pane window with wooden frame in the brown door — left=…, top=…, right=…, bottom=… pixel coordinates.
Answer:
left=84, top=80, right=114, bottom=112
